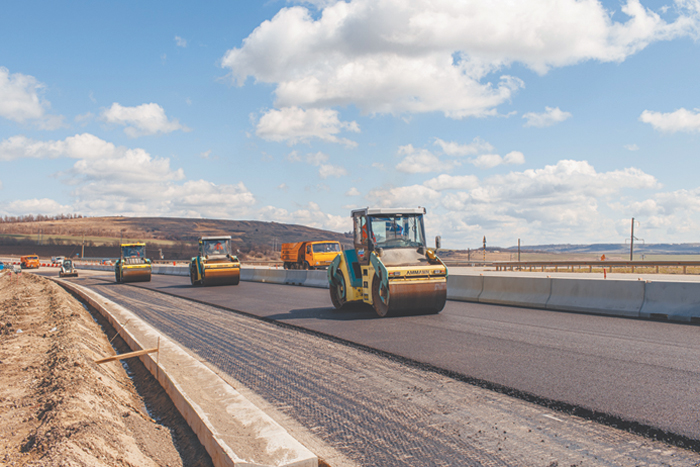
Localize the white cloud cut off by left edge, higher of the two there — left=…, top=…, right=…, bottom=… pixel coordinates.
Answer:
left=0, top=67, right=63, bottom=130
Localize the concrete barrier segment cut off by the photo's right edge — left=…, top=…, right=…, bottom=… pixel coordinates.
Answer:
left=639, top=282, right=700, bottom=322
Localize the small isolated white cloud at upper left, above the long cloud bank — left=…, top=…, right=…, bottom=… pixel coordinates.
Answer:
left=100, top=102, right=190, bottom=138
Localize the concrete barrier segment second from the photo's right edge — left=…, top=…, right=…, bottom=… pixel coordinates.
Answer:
left=545, top=279, right=645, bottom=318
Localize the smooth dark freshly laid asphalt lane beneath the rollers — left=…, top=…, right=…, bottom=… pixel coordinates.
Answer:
left=56, top=270, right=700, bottom=440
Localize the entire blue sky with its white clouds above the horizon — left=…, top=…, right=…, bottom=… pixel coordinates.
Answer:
left=0, top=0, right=700, bottom=248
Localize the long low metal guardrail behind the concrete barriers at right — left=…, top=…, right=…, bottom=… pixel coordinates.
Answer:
left=484, top=260, right=700, bottom=274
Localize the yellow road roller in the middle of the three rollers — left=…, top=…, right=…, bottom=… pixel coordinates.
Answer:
left=190, top=236, right=241, bottom=285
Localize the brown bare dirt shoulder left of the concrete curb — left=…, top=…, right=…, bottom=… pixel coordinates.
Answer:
left=0, top=273, right=211, bottom=466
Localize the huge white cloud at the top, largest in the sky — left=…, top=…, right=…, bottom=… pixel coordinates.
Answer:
left=221, top=0, right=698, bottom=118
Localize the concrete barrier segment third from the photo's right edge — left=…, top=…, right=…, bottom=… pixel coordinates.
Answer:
left=479, top=276, right=552, bottom=308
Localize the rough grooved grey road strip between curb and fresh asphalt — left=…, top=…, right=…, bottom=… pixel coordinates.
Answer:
left=50, top=277, right=700, bottom=467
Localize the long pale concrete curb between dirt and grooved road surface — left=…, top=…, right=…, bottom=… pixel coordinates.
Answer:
left=49, top=278, right=318, bottom=467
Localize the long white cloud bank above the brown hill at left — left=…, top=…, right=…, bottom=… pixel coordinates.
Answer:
left=0, top=133, right=256, bottom=217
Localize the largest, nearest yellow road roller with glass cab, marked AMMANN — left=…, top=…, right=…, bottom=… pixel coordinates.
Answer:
left=328, top=208, right=447, bottom=316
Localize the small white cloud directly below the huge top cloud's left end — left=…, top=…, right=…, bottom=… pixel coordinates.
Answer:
left=255, top=107, right=360, bottom=147
